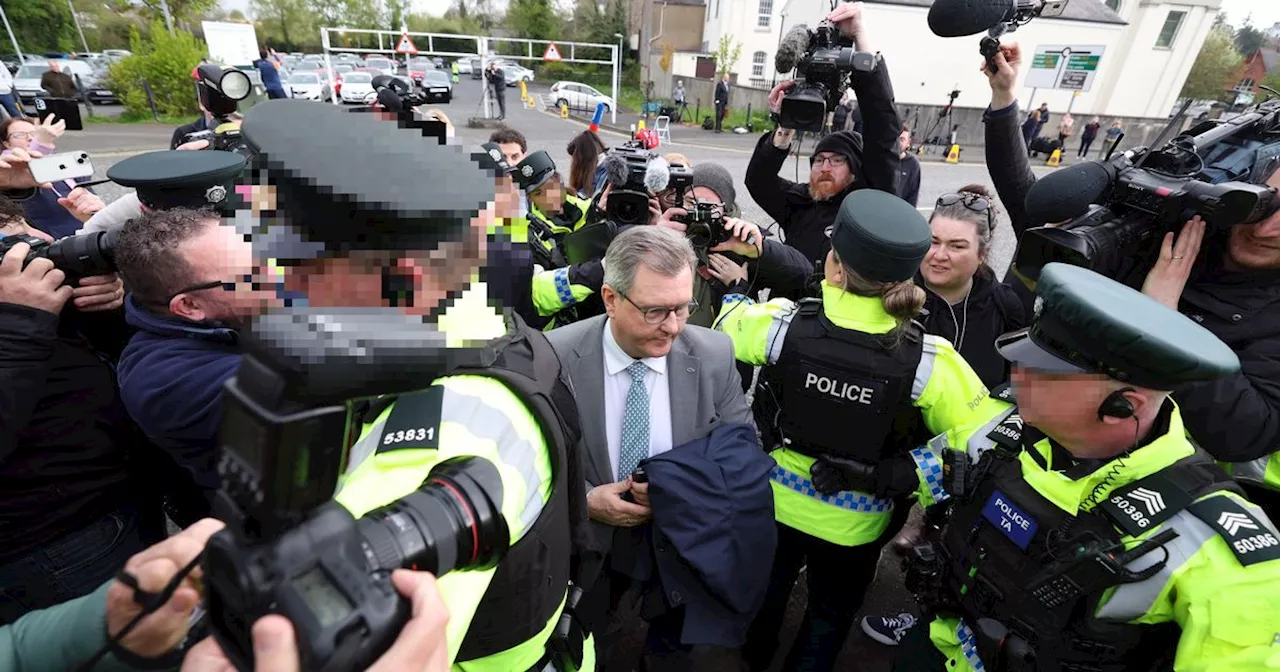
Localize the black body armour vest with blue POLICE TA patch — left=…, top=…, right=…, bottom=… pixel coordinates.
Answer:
left=938, top=411, right=1234, bottom=672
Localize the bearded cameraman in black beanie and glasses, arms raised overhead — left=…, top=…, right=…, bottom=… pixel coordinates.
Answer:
left=744, top=3, right=902, bottom=264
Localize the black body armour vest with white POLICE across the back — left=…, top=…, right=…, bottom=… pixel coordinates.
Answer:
left=756, top=298, right=924, bottom=462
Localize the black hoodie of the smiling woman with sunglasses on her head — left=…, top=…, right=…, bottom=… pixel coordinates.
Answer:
left=915, top=266, right=1029, bottom=388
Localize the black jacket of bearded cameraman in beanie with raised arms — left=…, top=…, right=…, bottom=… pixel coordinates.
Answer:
left=742, top=61, right=902, bottom=262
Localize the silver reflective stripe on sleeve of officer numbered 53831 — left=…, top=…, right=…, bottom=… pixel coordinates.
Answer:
left=347, top=376, right=550, bottom=536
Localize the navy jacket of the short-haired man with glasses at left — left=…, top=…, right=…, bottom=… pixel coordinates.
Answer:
left=119, top=294, right=241, bottom=524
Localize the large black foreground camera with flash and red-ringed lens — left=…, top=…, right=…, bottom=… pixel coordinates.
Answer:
left=202, top=308, right=509, bottom=672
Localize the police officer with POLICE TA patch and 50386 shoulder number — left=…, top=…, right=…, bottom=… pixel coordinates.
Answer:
left=896, top=264, right=1280, bottom=672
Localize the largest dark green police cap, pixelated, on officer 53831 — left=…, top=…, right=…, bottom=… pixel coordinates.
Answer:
left=241, top=100, right=494, bottom=259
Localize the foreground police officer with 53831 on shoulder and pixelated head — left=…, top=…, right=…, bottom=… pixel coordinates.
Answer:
left=235, top=100, right=594, bottom=672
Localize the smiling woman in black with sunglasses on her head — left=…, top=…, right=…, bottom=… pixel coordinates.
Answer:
left=918, top=184, right=1028, bottom=388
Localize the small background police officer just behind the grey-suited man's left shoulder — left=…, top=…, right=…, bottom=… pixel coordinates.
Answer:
left=512, top=151, right=607, bottom=329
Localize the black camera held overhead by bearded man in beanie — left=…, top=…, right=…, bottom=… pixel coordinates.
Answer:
left=778, top=20, right=879, bottom=133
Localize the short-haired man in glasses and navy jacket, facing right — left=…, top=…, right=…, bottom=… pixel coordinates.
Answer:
left=115, top=209, right=275, bottom=525
